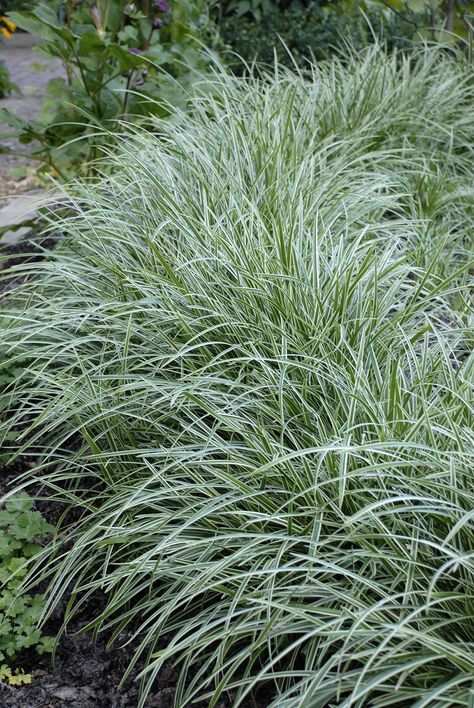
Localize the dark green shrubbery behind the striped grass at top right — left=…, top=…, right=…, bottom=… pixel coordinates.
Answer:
left=218, top=0, right=474, bottom=71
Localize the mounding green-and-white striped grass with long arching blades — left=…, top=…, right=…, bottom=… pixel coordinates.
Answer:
left=0, top=47, right=474, bottom=708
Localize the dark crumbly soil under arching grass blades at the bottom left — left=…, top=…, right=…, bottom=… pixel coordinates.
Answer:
left=0, top=457, right=272, bottom=708
